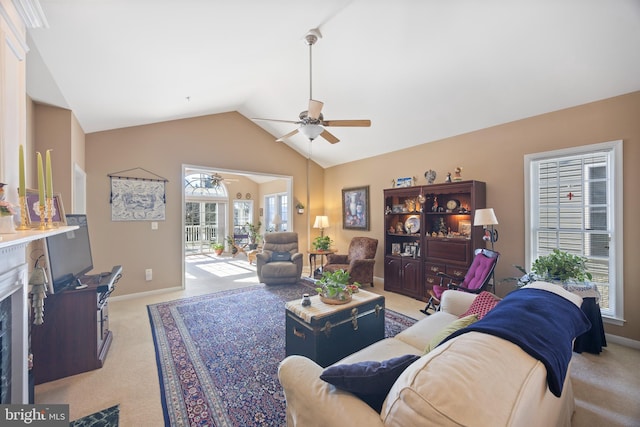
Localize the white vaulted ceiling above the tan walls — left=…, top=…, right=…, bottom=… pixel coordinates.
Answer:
left=27, top=0, right=640, bottom=167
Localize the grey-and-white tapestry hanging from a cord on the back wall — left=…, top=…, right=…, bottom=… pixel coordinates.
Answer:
left=108, top=168, right=169, bottom=221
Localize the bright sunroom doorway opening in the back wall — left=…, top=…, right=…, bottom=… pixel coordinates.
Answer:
left=182, top=165, right=293, bottom=292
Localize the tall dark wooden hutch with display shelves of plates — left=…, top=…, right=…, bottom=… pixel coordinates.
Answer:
left=384, top=181, right=486, bottom=299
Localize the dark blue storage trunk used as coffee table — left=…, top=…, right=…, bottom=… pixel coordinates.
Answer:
left=285, top=290, right=385, bottom=367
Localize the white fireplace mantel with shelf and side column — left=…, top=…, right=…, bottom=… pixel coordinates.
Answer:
left=0, top=226, right=78, bottom=404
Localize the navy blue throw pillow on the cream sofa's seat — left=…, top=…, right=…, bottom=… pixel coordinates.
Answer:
left=320, top=354, right=420, bottom=412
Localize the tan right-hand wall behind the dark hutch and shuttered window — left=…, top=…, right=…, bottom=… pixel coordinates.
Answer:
left=325, top=92, right=640, bottom=340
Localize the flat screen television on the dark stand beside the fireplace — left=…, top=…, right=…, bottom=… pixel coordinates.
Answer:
left=45, top=214, right=93, bottom=293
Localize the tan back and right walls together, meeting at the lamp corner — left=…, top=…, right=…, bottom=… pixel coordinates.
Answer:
left=36, top=92, right=640, bottom=340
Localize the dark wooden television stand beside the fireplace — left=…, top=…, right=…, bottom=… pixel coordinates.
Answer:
left=31, top=265, right=122, bottom=384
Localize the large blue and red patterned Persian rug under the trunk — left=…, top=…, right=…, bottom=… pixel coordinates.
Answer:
left=148, top=283, right=415, bottom=427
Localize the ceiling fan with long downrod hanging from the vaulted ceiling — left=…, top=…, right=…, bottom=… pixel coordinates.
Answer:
left=252, top=29, right=371, bottom=144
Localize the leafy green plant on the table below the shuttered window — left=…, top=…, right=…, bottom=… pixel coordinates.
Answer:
left=508, top=249, right=593, bottom=287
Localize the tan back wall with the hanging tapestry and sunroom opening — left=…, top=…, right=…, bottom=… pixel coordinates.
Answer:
left=86, top=113, right=324, bottom=295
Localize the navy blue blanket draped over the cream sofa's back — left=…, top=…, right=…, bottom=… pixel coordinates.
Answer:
left=443, top=288, right=591, bottom=397
